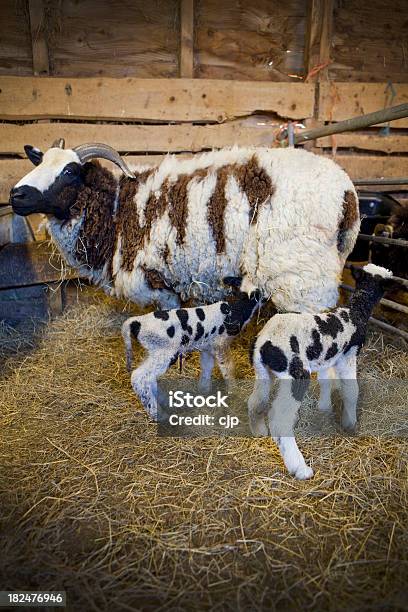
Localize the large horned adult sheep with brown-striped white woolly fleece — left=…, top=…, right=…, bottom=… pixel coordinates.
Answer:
left=10, top=137, right=359, bottom=312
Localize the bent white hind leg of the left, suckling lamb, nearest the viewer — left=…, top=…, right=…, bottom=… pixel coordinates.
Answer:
left=130, top=354, right=172, bottom=421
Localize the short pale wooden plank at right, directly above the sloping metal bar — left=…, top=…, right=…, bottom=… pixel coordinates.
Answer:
left=318, top=82, right=408, bottom=128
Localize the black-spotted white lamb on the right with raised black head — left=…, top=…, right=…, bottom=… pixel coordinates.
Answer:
left=248, top=264, right=397, bottom=479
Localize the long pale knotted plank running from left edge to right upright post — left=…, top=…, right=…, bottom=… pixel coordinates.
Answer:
left=0, top=77, right=314, bottom=123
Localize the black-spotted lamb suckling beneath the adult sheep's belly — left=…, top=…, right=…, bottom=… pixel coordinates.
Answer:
left=122, top=291, right=262, bottom=420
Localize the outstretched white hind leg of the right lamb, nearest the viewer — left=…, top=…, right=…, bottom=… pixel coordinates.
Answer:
left=268, top=373, right=313, bottom=480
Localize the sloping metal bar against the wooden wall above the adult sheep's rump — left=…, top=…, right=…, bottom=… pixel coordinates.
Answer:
left=295, top=104, right=408, bottom=144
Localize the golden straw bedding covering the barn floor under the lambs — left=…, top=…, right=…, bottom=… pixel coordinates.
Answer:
left=0, top=292, right=408, bottom=610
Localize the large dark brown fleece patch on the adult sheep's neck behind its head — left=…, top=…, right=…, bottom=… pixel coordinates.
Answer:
left=71, top=162, right=117, bottom=269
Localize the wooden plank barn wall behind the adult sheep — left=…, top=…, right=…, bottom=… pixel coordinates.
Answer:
left=0, top=0, right=408, bottom=204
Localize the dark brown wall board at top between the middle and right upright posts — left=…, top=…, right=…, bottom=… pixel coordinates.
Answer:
left=195, top=0, right=306, bottom=81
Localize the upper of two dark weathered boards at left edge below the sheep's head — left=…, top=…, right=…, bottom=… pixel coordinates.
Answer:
left=0, top=242, right=78, bottom=289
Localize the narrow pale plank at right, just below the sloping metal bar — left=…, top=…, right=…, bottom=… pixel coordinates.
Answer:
left=315, top=132, right=408, bottom=153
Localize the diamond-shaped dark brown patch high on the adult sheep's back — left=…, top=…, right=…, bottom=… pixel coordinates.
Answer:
left=234, top=155, right=275, bottom=222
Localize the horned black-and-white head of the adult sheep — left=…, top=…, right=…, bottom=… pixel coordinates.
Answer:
left=10, top=138, right=134, bottom=219
